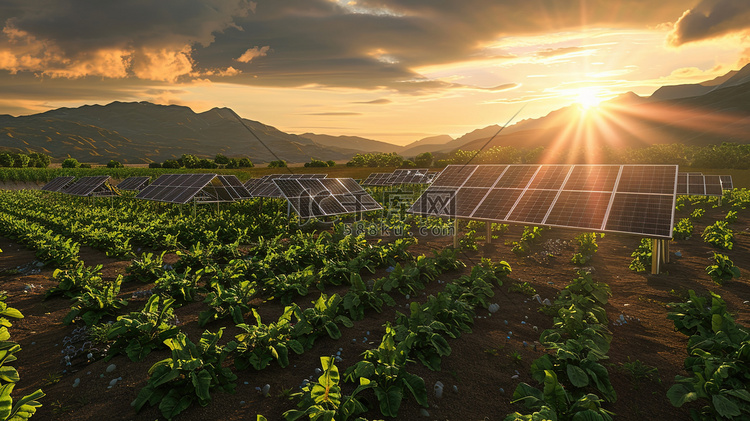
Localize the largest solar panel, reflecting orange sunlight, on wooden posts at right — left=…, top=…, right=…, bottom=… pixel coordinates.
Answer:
left=409, top=164, right=677, bottom=238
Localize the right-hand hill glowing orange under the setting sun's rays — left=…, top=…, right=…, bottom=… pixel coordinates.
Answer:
left=461, top=72, right=750, bottom=160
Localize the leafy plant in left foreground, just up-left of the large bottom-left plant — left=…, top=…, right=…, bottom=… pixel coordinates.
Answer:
left=106, top=295, right=180, bottom=361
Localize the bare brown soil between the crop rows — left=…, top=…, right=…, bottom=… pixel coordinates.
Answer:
left=0, top=201, right=750, bottom=421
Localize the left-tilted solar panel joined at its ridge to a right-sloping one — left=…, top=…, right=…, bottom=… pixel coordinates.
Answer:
left=135, top=174, right=216, bottom=204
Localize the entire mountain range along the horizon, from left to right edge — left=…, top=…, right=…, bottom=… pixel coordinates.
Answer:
left=0, top=65, right=750, bottom=163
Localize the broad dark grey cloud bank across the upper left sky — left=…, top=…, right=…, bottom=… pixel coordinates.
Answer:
left=0, top=0, right=695, bottom=89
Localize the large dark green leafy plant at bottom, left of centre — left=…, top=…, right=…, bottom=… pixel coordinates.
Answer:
left=131, top=328, right=237, bottom=420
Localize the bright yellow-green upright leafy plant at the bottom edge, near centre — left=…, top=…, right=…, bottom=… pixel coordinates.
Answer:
left=284, top=357, right=373, bottom=421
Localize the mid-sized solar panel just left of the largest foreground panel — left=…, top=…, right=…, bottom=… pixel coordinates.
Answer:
left=273, top=177, right=382, bottom=218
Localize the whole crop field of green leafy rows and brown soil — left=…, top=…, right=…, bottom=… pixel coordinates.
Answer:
left=0, top=189, right=750, bottom=420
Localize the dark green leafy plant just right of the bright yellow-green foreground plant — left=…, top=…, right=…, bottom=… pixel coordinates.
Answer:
left=344, top=324, right=427, bottom=417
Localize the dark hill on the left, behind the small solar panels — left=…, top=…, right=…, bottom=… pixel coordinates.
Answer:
left=0, top=102, right=356, bottom=163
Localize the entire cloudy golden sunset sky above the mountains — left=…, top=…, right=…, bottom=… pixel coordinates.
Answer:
left=0, top=0, right=750, bottom=145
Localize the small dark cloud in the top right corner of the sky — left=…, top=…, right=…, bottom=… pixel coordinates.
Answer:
left=667, top=0, right=750, bottom=47
